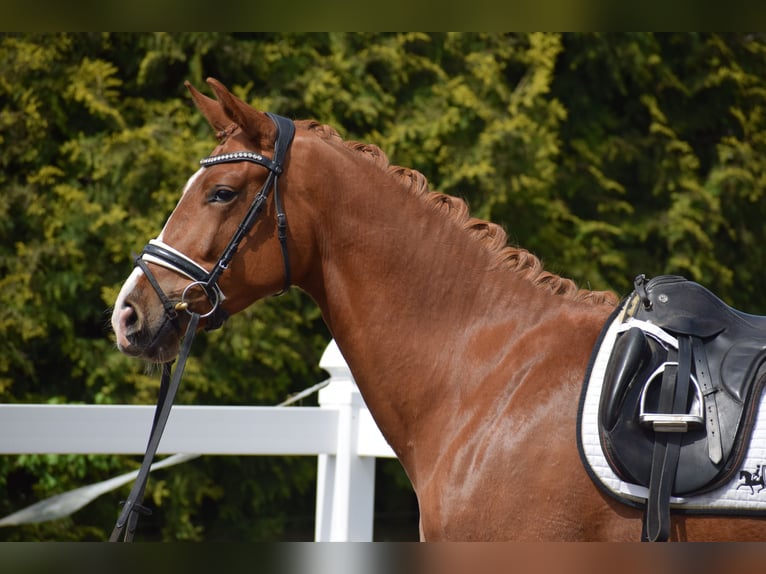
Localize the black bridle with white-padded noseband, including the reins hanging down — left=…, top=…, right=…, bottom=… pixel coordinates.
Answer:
left=109, top=113, right=295, bottom=542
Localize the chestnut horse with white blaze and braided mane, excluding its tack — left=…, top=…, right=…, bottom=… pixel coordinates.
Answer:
left=112, top=79, right=766, bottom=541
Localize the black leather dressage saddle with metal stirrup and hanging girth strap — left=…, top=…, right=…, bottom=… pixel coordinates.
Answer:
left=599, top=275, right=766, bottom=540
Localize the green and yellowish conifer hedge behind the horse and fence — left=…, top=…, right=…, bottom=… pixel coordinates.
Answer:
left=0, top=33, right=766, bottom=541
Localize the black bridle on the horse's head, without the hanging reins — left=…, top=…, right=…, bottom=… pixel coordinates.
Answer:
left=135, top=113, right=295, bottom=330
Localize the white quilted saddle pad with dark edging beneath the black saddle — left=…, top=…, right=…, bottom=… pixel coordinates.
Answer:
left=577, top=308, right=766, bottom=514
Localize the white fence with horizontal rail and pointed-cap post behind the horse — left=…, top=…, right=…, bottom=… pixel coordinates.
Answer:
left=0, top=341, right=395, bottom=541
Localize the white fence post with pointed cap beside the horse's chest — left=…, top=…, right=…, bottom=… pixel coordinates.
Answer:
left=314, top=340, right=375, bottom=542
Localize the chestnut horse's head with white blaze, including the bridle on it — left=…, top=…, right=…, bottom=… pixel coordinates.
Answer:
left=112, top=79, right=308, bottom=362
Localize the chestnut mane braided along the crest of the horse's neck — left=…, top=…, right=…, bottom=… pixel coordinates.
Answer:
left=296, top=120, right=619, bottom=305
